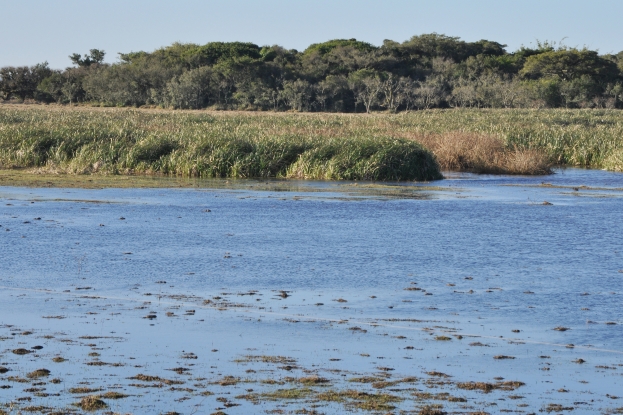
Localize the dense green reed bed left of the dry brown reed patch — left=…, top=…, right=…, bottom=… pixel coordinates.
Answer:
left=0, top=106, right=442, bottom=180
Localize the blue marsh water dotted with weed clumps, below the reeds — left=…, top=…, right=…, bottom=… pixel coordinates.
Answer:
left=0, top=169, right=623, bottom=414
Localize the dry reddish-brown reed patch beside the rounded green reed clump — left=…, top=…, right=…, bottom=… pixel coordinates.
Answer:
left=412, top=131, right=552, bottom=175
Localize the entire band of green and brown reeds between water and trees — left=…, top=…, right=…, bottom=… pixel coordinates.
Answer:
left=0, top=105, right=623, bottom=180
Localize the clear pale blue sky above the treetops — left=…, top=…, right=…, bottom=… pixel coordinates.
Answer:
left=0, top=0, right=623, bottom=68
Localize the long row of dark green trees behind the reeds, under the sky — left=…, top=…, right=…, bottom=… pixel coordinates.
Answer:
left=0, top=33, right=623, bottom=112
